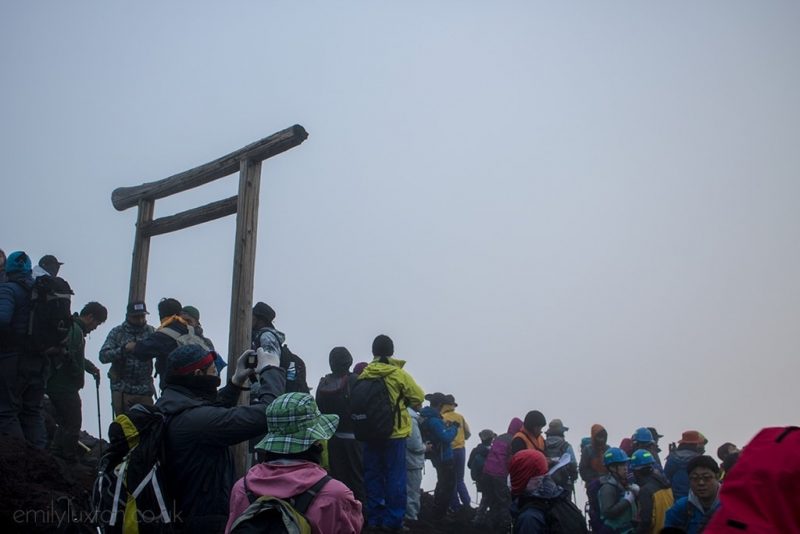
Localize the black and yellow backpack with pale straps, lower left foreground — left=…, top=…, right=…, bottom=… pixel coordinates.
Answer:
left=92, top=404, right=184, bottom=534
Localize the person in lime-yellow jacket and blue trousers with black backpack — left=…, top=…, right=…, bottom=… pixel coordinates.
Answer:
left=351, top=334, right=424, bottom=532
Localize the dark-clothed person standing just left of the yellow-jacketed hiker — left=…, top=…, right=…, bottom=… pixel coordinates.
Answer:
left=316, top=347, right=366, bottom=503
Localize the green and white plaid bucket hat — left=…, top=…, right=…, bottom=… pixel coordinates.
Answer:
left=256, top=393, right=339, bottom=454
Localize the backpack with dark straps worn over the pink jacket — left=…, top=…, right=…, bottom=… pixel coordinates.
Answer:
left=231, top=475, right=331, bottom=534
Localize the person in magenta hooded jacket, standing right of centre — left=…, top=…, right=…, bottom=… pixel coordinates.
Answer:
left=483, top=417, right=522, bottom=532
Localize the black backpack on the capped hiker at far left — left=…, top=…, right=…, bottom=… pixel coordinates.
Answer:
left=26, top=276, right=74, bottom=352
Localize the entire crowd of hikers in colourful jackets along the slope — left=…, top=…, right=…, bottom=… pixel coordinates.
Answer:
left=0, top=251, right=800, bottom=534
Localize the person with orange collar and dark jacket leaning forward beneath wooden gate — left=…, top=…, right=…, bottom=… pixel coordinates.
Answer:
left=132, top=297, right=211, bottom=390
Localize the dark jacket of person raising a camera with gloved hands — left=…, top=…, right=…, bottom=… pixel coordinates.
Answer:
left=156, top=366, right=286, bottom=526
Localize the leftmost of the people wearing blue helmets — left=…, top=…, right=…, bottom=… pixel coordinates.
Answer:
left=592, top=447, right=639, bottom=534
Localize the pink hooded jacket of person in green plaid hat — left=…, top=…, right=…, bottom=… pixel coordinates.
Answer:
left=225, top=460, right=364, bottom=534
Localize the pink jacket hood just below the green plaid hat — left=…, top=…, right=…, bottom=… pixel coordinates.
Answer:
left=245, top=460, right=327, bottom=499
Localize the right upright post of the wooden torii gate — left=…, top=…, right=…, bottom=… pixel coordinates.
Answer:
left=228, top=159, right=266, bottom=478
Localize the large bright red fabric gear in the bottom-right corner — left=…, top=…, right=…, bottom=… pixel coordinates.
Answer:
left=703, top=426, right=800, bottom=534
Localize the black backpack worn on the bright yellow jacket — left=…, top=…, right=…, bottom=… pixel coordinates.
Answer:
left=350, top=377, right=404, bottom=441
